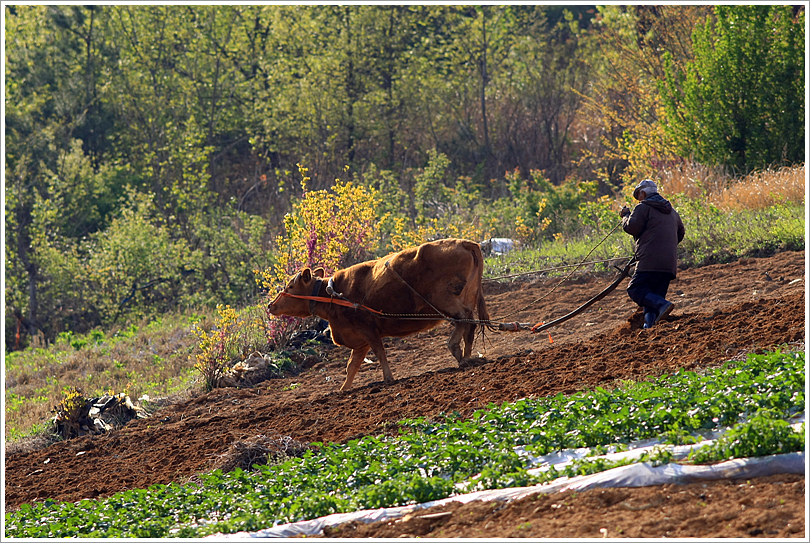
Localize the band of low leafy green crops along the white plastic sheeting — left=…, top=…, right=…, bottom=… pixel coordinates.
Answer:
left=5, top=351, right=804, bottom=537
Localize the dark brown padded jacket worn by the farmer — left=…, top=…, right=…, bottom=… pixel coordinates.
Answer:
left=622, top=194, right=686, bottom=278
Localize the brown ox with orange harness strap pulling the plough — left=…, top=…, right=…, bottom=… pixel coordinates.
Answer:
left=268, top=239, right=489, bottom=391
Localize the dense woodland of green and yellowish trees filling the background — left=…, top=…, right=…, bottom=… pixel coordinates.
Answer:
left=4, top=5, right=805, bottom=348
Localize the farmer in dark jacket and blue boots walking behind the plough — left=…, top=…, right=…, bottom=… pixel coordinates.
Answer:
left=619, top=179, right=686, bottom=328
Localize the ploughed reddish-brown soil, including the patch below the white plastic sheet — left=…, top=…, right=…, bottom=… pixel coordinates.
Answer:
left=5, top=251, right=806, bottom=538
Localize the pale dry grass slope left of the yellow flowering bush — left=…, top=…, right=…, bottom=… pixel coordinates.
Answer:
left=4, top=315, right=211, bottom=442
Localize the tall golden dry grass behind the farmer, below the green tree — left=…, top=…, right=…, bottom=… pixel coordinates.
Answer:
left=657, top=163, right=806, bottom=212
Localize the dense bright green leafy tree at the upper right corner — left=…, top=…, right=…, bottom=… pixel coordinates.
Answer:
left=660, top=5, right=806, bottom=172
